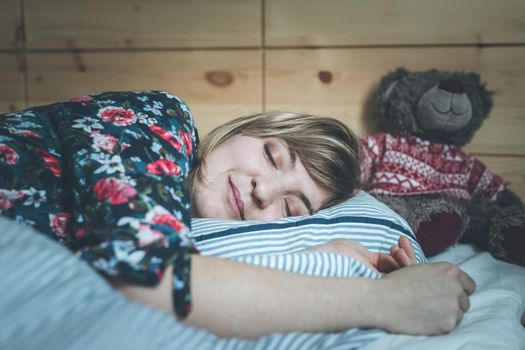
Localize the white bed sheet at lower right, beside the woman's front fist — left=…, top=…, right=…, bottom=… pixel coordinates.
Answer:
left=364, top=244, right=525, bottom=350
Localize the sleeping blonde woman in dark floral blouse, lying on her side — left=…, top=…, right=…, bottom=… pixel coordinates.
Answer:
left=0, top=91, right=475, bottom=337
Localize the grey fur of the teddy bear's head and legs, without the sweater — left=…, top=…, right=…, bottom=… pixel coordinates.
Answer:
left=370, top=67, right=525, bottom=265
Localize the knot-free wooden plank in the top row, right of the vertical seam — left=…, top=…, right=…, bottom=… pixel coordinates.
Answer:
left=265, top=0, right=525, bottom=46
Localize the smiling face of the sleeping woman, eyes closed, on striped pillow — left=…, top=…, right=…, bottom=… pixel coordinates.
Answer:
left=192, top=135, right=328, bottom=221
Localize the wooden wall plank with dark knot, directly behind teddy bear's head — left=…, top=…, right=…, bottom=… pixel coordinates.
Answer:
left=265, top=47, right=525, bottom=155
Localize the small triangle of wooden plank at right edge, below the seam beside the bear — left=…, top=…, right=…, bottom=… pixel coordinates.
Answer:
left=478, top=156, right=525, bottom=201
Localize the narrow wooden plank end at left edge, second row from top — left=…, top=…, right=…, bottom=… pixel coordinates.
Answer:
left=0, top=53, right=25, bottom=114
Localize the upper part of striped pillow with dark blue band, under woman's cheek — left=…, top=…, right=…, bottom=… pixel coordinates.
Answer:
left=192, top=192, right=426, bottom=263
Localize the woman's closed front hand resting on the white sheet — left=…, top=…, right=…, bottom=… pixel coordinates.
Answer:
left=371, top=263, right=476, bottom=335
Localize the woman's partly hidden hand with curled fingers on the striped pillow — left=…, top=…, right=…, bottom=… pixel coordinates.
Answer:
left=305, top=236, right=416, bottom=273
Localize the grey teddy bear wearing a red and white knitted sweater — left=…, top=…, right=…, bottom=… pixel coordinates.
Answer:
left=361, top=67, right=525, bottom=266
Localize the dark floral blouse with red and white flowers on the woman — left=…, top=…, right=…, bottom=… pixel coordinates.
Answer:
left=0, top=91, right=198, bottom=317
